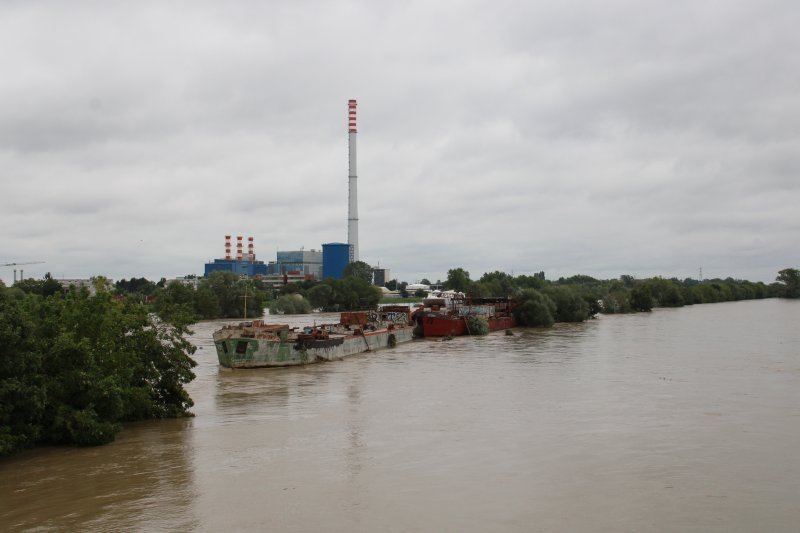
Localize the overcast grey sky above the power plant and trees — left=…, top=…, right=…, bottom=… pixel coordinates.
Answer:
left=0, top=0, right=800, bottom=284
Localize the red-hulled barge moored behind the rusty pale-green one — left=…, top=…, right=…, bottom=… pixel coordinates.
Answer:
left=412, top=292, right=517, bottom=337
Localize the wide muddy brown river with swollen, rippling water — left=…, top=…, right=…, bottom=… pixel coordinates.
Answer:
left=0, top=299, right=800, bottom=532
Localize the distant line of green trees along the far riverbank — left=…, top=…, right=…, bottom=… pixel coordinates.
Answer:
left=116, top=261, right=800, bottom=325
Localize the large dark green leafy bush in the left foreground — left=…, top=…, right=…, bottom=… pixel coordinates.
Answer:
left=0, top=289, right=196, bottom=455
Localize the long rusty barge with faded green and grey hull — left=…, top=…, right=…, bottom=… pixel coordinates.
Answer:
left=213, top=308, right=413, bottom=368
